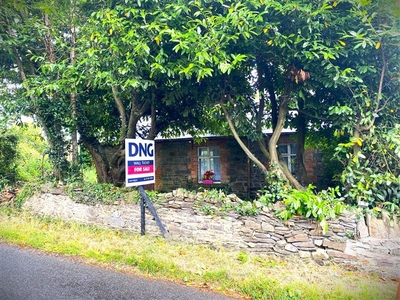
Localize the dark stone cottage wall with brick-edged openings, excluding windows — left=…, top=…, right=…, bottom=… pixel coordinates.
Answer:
left=154, top=134, right=322, bottom=199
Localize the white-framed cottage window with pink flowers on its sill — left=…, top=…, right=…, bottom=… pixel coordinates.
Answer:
left=198, top=147, right=221, bottom=182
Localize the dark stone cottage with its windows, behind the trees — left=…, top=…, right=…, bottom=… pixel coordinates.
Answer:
left=153, top=132, right=322, bottom=199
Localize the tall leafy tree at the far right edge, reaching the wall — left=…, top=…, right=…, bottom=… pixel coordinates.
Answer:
left=330, top=1, right=400, bottom=206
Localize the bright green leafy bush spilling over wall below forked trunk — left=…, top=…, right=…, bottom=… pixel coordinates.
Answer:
left=278, top=185, right=345, bottom=233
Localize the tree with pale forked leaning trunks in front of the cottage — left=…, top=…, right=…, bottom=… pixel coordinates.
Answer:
left=155, top=1, right=374, bottom=189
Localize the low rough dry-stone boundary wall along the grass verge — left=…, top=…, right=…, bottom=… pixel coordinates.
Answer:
left=24, top=190, right=400, bottom=278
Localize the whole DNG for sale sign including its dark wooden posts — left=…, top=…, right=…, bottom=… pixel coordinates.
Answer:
left=125, top=139, right=168, bottom=238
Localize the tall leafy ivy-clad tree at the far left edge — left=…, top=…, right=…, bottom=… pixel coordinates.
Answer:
left=0, top=1, right=86, bottom=180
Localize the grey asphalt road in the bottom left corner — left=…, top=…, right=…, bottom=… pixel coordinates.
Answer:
left=0, top=244, right=236, bottom=300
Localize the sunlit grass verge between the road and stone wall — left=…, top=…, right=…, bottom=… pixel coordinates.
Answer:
left=0, top=208, right=396, bottom=300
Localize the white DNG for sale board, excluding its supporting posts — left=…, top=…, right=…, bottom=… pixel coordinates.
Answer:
left=125, top=139, right=156, bottom=187
